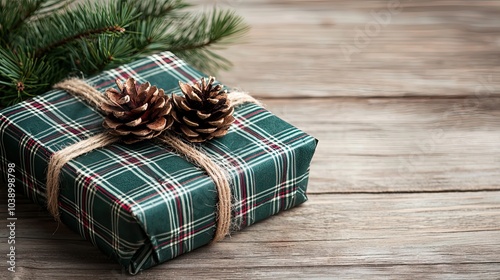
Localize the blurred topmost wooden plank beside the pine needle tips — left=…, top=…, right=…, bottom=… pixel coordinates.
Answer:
left=190, top=0, right=500, bottom=97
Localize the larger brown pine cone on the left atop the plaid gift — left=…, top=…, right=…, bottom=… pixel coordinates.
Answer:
left=101, top=78, right=173, bottom=144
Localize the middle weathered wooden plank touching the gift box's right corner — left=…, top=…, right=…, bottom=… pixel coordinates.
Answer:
left=263, top=98, right=500, bottom=193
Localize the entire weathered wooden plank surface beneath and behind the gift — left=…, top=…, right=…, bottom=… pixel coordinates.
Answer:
left=0, top=0, right=500, bottom=279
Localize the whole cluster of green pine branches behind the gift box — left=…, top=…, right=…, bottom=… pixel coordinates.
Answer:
left=0, top=0, right=248, bottom=107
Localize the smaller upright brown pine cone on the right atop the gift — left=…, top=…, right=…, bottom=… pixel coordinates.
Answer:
left=172, top=77, right=234, bottom=142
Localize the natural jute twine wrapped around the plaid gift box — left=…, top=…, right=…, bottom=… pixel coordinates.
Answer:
left=46, top=78, right=261, bottom=241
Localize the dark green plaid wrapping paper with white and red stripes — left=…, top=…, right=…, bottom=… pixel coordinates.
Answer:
left=0, top=52, right=316, bottom=274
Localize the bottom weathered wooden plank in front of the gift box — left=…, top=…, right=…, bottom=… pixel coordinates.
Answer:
left=0, top=188, right=500, bottom=279
